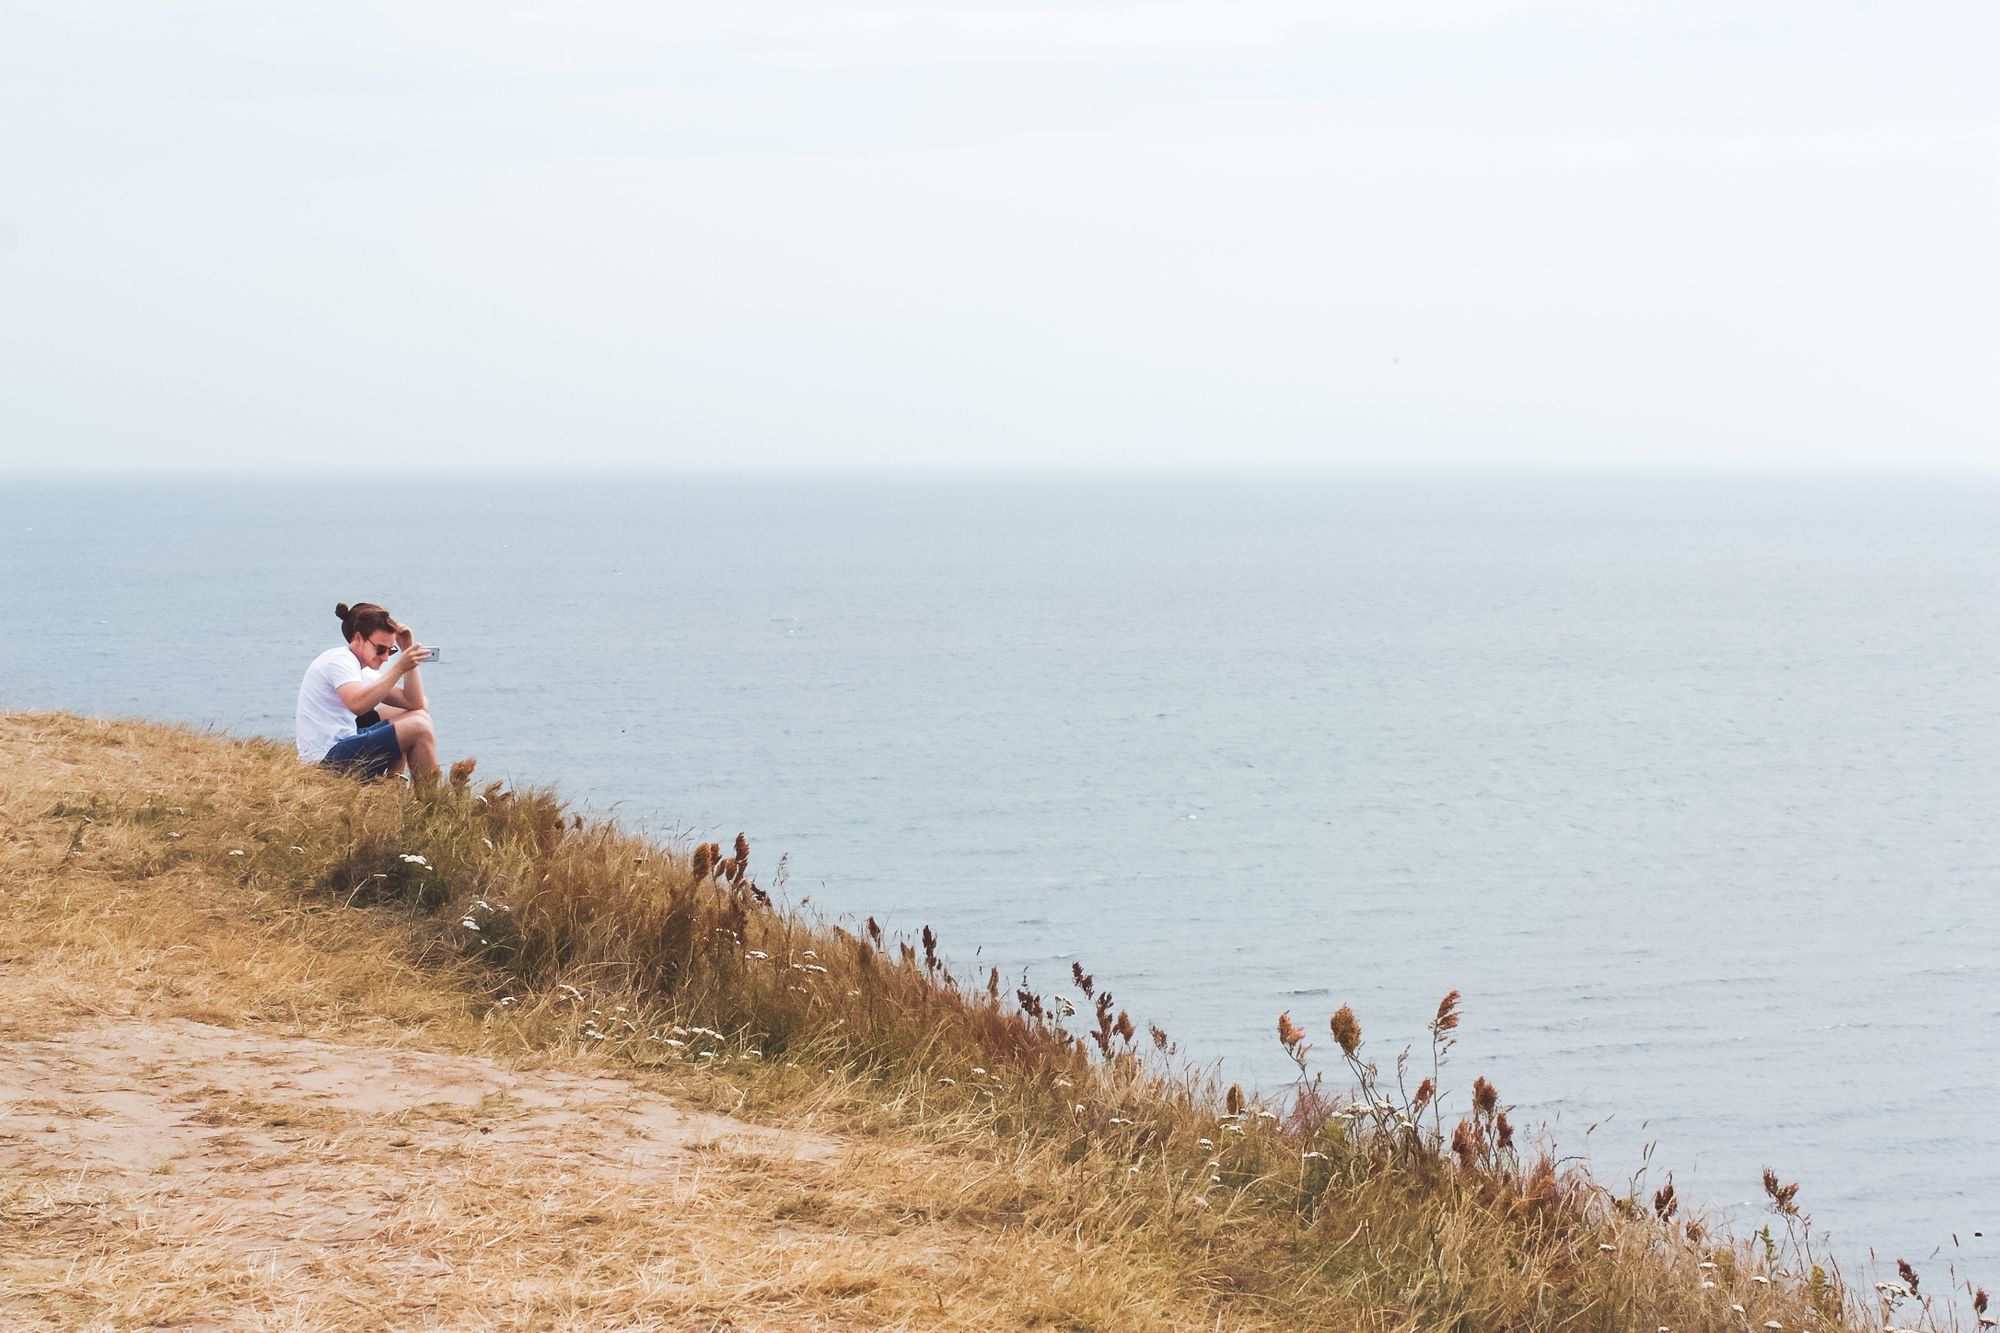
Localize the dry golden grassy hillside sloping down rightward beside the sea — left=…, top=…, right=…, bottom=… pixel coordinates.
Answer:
left=0, top=715, right=1958, bottom=1333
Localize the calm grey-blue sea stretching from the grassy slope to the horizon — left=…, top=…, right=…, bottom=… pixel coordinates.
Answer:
left=0, top=472, right=2000, bottom=1289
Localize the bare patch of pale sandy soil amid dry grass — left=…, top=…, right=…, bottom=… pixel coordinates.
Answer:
left=0, top=1019, right=838, bottom=1329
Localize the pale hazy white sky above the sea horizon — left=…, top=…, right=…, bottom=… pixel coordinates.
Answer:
left=0, top=0, right=2000, bottom=466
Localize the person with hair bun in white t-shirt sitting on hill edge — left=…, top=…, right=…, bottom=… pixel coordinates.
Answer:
left=294, top=602, right=438, bottom=779
